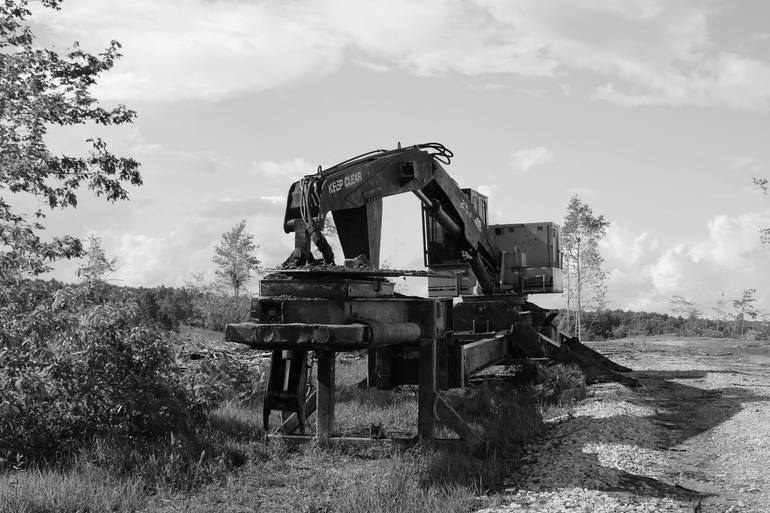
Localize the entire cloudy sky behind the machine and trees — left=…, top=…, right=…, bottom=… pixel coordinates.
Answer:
left=16, top=0, right=770, bottom=311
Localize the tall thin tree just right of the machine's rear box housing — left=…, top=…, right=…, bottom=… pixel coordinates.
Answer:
left=561, top=195, right=610, bottom=338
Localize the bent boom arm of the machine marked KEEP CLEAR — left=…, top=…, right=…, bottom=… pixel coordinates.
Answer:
left=284, top=143, right=500, bottom=293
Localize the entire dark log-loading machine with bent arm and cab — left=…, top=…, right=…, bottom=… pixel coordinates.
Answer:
left=226, top=143, right=633, bottom=441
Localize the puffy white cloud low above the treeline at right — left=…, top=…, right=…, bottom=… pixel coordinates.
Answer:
left=601, top=211, right=770, bottom=312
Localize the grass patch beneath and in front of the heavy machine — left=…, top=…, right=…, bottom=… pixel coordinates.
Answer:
left=0, top=330, right=585, bottom=513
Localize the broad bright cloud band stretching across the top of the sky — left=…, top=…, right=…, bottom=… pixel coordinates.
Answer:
left=31, top=0, right=770, bottom=109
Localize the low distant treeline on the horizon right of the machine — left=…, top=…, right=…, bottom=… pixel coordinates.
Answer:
left=562, top=310, right=770, bottom=340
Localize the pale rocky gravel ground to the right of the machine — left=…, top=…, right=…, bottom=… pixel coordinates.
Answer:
left=476, top=339, right=770, bottom=513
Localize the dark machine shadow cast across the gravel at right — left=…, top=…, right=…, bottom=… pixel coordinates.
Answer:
left=510, top=371, right=770, bottom=500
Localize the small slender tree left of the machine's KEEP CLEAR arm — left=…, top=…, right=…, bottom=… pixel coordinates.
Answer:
left=213, top=220, right=260, bottom=299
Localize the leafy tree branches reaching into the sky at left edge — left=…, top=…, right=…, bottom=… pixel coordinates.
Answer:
left=0, top=0, right=142, bottom=277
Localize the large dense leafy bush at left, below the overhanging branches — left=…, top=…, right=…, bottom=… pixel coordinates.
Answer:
left=0, top=282, right=202, bottom=463
